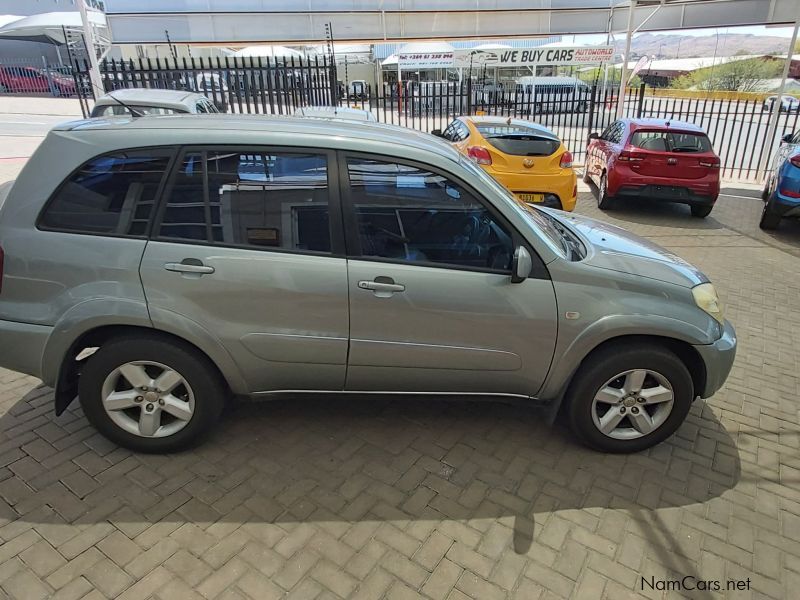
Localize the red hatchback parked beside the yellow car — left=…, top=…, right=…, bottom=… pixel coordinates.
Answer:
left=583, top=119, right=720, bottom=217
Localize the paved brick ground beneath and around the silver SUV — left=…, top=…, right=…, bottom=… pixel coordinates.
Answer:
left=0, top=172, right=800, bottom=600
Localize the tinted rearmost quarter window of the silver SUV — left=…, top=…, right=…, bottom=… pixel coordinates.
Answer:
left=40, top=149, right=172, bottom=235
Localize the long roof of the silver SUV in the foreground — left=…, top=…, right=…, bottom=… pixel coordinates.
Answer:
left=53, top=114, right=460, bottom=162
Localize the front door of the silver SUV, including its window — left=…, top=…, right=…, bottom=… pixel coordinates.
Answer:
left=340, top=155, right=557, bottom=396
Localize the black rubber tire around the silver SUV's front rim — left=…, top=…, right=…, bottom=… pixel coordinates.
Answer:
left=566, top=342, right=695, bottom=453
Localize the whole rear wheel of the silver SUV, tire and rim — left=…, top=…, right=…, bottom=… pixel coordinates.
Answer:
left=78, top=336, right=226, bottom=452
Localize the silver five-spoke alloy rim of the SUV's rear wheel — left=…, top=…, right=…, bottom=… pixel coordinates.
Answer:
left=101, top=360, right=194, bottom=437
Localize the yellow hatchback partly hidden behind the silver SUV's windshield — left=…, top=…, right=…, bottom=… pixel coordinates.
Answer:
left=431, top=116, right=578, bottom=211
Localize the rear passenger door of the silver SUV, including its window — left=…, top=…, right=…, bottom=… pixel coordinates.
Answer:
left=141, top=147, right=348, bottom=392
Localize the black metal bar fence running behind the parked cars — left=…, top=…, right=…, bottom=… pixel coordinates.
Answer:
left=72, top=57, right=800, bottom=180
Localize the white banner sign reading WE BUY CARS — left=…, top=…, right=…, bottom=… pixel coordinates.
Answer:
left=452, top=46, right=614, bottom=68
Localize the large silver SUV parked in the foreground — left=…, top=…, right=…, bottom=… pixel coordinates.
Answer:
left=0, top=115, right=736, bottom=452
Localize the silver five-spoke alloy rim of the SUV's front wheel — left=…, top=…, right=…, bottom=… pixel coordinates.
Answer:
left=592, top=369, right=675, bottom=440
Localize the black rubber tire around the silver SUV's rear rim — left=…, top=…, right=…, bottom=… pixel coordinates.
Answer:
left=78, top=334, right=228, bottom=453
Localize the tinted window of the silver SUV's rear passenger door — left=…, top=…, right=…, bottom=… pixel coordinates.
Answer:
left=160, top=150, right=331, bottom=252
